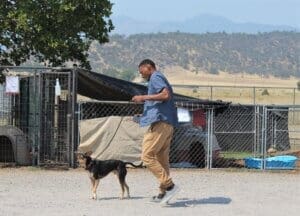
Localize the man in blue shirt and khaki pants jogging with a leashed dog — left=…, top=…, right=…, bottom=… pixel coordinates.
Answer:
left=132, top=59, right=179, bottom=204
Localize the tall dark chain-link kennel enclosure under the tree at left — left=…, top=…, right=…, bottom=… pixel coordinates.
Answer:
left=0, top=67, right=77, bottom=166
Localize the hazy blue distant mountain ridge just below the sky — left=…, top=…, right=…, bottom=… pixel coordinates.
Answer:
left=113, top=14, right=300, bottom=35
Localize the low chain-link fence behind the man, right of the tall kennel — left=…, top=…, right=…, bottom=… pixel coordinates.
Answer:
left=79, top=101, right=300, bottom=169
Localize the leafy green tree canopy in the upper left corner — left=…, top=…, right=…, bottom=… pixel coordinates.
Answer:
left=0, top=0, right=113, bottom=69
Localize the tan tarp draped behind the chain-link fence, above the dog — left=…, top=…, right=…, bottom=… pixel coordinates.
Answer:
left=78, top=116, right=147, bottom=162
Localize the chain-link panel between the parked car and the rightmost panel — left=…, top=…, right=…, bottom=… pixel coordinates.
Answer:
left=212, top=105, right=261, bottom=168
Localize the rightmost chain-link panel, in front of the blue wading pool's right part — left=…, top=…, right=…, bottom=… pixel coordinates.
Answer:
left=263, top=106, right=300, bottom=169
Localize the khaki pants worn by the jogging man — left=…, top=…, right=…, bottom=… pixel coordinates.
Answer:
left=142, top=122, right=173, bottom=192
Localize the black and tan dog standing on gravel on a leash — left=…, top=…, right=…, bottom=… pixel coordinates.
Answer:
left=78, top=152, right=142, bottom=199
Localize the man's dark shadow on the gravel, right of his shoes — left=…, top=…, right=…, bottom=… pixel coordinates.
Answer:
left=168, top=197, right=231, bottom=207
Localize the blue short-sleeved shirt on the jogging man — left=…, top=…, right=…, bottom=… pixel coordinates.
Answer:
left=140, top=71, right=178, bottom=127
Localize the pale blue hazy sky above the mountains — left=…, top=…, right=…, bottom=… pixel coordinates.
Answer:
left=111, top=0, right=300, bottom=27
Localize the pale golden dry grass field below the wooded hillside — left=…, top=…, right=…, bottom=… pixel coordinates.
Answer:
left=154, top=67, right=300, bottom=105
